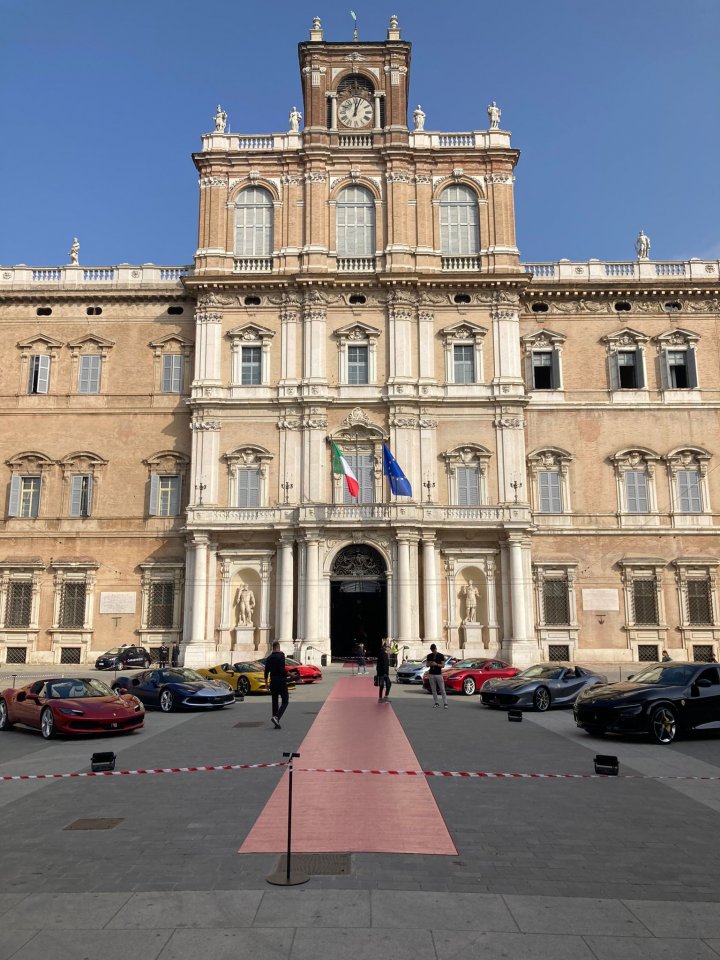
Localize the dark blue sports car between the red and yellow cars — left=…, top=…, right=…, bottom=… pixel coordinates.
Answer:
left=113, top=667, right=235, bottom=713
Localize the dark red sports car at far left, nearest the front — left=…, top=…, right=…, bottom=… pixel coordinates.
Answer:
left=0, top=677, right=145, bottom=740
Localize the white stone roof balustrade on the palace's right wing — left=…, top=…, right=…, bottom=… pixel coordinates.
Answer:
left=523, top=259, right=720, bottom=284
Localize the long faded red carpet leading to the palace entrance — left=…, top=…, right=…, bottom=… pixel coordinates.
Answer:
left=239, top=676, right=457, bottom=855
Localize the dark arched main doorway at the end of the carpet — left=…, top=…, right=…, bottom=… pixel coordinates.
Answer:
left=330, top=544, right=387, bottom=657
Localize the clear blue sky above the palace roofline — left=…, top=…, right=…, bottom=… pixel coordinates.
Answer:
left=0, top=0, right=720, bottom=266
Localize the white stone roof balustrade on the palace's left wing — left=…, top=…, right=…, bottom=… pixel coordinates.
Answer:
left=0, top=263, right=192, bottom=291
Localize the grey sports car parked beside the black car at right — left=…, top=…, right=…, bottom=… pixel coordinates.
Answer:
left=480, top=663, right=607, bottom=712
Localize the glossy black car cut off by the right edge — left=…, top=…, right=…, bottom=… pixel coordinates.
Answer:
left=574, top=661, right=720, bottom=743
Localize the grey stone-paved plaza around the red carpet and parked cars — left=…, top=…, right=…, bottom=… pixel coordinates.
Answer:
left=0, top=667, right=720, bottom=960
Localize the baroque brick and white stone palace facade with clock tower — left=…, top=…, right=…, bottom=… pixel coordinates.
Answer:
left=0, top=18, right=720, bottom=666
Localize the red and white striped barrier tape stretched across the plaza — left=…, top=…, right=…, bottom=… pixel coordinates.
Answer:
left=0, top=760, right=720, bottom=781
